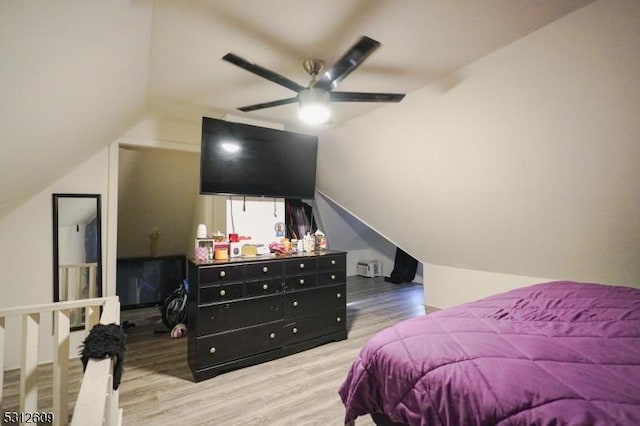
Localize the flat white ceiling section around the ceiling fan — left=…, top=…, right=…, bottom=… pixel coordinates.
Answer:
left=149, top=0, right=591, bottom=131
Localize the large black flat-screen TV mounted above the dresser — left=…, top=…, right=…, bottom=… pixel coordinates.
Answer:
left=200, top=117, right=318, bottom=198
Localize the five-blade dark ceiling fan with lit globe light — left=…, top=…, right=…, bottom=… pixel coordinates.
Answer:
left=222, top=36, right=405, bottom=124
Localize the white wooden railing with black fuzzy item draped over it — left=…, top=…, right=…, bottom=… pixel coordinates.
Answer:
left=0, top=296, right=122, bottom=425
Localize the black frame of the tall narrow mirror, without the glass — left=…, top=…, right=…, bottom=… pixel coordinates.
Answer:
left=52, top=194, right=103, bottom=320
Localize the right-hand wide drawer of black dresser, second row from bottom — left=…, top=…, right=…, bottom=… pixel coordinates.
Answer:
left=284, top=284, right=346, bottom=319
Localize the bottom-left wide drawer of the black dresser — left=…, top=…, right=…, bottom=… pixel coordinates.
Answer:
left=196, top=321, right=284, bottom=368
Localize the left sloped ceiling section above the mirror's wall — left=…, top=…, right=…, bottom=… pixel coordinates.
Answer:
left=0, top=0, right=153, bottom=218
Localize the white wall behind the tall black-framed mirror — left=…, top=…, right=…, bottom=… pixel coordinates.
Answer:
left=0, top=147, right=115, bottom=369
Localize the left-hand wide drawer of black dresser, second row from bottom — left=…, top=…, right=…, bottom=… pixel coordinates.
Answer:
left=198, top=294, right=283, bottom=336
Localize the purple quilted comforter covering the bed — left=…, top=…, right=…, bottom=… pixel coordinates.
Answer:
left=339, top=281, right=640, bottom=426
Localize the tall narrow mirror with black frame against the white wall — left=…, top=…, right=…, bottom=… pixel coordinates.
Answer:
left=53, top=194, right=102, bottom=329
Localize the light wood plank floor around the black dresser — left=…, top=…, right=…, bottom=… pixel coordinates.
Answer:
left=5, top=277, right=431, bottom=426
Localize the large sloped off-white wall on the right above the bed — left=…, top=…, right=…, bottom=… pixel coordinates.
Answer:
left=317, top=0, right=640, bottom=307
